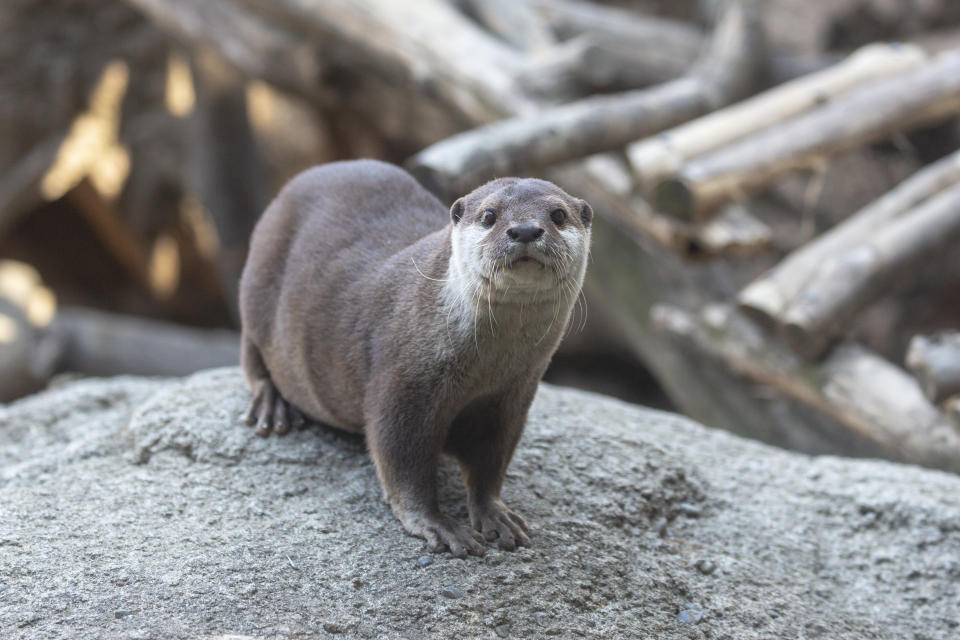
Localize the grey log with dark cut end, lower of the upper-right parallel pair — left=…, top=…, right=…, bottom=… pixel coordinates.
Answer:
left=652, top=51, right=960, bottom=220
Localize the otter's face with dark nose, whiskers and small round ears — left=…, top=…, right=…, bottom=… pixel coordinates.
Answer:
left=450, top=178, right=593, bottom=294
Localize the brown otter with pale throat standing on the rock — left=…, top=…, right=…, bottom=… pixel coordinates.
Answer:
left=240, top=160, right=593, bottom=558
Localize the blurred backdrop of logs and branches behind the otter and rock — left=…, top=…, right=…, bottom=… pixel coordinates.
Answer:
left=0, top=0, right=960, bottom=471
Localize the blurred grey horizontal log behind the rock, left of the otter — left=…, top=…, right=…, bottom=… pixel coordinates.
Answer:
left=50, top=308, right=240, bottom=376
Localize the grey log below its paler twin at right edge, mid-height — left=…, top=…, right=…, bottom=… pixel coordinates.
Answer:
left=783, top=184, right=960, bottom=358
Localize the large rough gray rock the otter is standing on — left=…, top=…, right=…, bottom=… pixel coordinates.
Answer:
left=0, top=369, right=960, bottom=640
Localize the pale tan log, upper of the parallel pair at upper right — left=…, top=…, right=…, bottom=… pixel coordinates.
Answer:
left=627, top=44, right=925, bottom=196
